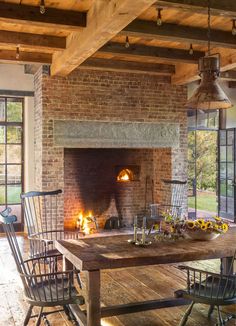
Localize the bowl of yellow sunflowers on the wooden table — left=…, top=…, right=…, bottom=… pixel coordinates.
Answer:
left=185, top=216, right=229, bottom=240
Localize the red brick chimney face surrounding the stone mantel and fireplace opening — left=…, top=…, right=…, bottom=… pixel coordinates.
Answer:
left=35, top=69, right=187, bottom=227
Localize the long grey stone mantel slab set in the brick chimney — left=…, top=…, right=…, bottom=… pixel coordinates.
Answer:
left=53, top=120, right=180, bottom=148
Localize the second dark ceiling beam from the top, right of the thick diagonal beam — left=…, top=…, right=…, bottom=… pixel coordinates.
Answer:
left=120, top=20, right=236, bottom=49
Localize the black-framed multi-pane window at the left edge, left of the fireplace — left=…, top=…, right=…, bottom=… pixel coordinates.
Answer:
left=0, top=97, right=24, bottom=230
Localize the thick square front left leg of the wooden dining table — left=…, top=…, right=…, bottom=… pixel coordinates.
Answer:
left=86, top=270, right=101, bottom=326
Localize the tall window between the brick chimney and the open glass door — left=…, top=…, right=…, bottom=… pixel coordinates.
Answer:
left=188, top=110, right=219, bottom=218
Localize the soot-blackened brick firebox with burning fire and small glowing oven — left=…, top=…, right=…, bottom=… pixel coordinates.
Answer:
left=64, top=148, right=170, bottom=228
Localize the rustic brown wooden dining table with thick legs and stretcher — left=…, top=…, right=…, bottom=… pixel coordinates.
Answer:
left=56, top=227, right=236, bottom=326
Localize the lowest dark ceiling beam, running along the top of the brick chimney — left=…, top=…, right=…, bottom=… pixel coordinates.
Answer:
left=79, top=58, right=175, bottom=76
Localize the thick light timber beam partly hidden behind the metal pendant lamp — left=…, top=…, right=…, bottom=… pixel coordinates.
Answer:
left=171, top=49, right=236, bottom=85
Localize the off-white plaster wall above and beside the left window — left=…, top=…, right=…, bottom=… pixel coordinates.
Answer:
left=0, top=64, right=34, bottom=191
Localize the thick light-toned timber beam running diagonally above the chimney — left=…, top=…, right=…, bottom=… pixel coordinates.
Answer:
left=51, top=0, right=156, bottom=76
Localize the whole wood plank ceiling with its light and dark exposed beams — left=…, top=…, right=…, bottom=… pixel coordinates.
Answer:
left=0, top=0, right=236, bottom=84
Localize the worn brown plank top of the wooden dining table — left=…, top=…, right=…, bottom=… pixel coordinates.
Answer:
left=56, top=228, right=236, bottom=270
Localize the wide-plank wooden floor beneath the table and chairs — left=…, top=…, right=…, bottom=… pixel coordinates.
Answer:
left=0, top=236, right=236, bottom=326
